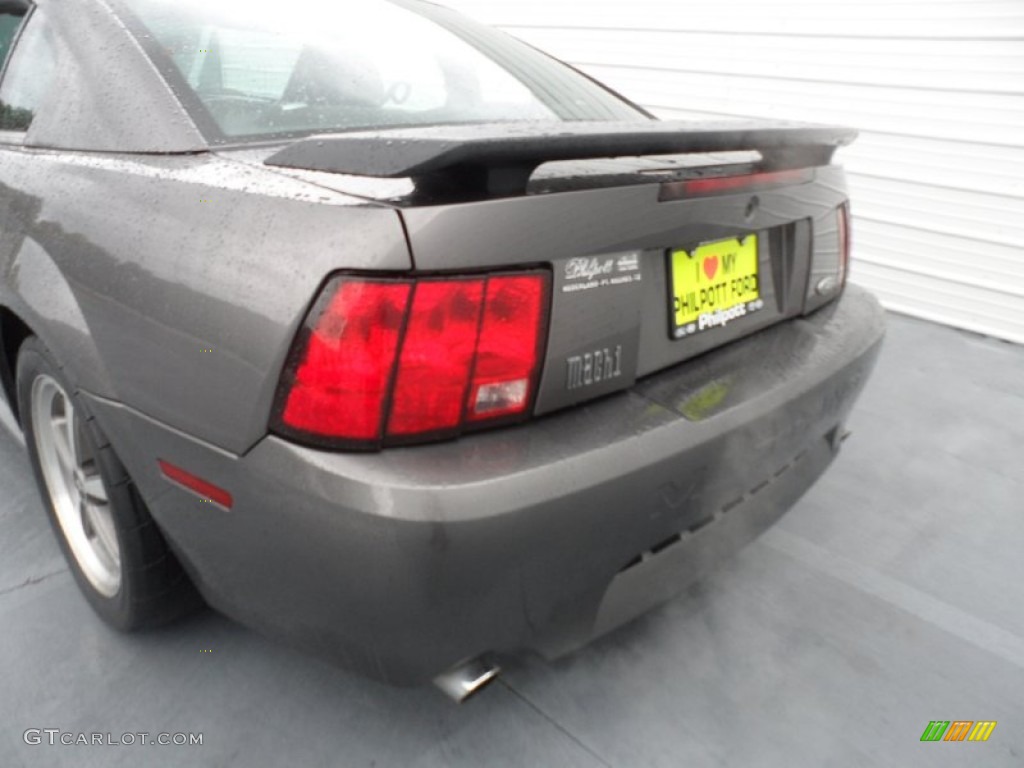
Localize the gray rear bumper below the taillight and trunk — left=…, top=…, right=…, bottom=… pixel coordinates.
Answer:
left=95, top=287, right=884, bottom=683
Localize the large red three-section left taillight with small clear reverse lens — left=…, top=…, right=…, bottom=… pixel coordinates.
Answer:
left=274, top=271, right=549, bottom=449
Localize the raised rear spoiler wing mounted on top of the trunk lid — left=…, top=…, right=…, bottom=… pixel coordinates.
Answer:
left=264, top=121, right=857, bottom=199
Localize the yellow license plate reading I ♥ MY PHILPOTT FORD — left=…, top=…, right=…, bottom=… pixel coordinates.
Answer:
left=669, top=234, right=764, bottom=339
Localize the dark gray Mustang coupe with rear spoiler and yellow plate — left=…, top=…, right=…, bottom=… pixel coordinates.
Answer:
left=0, top=0, right=884, bottom=699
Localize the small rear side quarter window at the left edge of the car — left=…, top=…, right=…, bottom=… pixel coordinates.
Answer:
left=0, top=9, right=56, bottom=131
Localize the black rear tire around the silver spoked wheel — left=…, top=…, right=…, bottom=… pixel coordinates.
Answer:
left=16, top=336, right=202, bottom=631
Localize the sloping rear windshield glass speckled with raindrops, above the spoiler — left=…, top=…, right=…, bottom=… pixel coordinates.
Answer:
left=116, top=0, right=641, bottom=141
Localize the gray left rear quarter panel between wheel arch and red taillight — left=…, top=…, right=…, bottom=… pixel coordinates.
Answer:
left=0, top=147, right=411, bottom=453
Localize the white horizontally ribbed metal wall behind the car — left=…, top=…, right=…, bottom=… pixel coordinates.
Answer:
left=446, top=0, right=1024, bottom=343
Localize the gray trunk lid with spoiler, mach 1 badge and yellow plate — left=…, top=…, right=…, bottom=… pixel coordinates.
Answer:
left=243, top=122, right=855, bottom=414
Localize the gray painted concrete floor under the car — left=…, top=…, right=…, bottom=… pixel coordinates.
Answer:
left=0, top=316, right=1024, bottom=768
